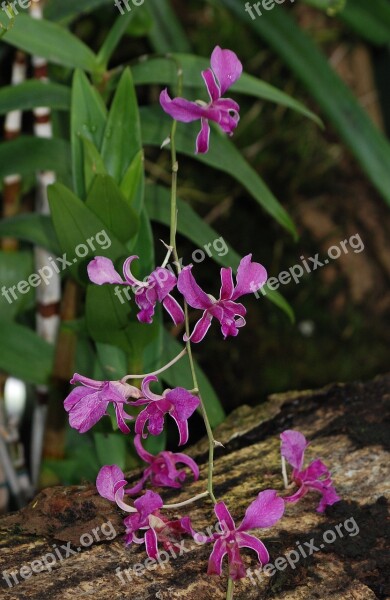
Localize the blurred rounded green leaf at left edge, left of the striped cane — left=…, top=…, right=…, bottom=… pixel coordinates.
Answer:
left=0, top=252, right=34, bottom=319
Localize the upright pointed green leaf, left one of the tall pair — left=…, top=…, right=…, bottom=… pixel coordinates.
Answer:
left=71, top=70, right=107, bottom=199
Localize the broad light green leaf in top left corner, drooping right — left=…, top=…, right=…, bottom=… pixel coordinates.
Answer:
left=3, top=13, right=99, bottom=72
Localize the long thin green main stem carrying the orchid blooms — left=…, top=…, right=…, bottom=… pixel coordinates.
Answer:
left=169, top=82, right=217, bottom=504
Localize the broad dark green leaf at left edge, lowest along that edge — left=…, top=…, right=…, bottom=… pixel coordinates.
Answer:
left=0, top=319, right=54, bottom=385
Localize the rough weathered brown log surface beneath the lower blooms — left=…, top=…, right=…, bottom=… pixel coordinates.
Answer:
left=0, top=375, right=390, bottom=600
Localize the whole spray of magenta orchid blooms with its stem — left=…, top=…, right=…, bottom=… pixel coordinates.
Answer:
left=64, top=46, right=339, bottom=600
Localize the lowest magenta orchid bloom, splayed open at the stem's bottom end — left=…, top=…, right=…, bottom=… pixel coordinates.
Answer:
left=207, top=490, right=284, bottom=579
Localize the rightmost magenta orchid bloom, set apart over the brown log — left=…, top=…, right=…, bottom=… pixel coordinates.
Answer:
left=280, top=429, right=341, bottom=513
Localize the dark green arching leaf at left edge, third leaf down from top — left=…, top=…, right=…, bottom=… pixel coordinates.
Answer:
left=0, top=136, right=70, bottom=182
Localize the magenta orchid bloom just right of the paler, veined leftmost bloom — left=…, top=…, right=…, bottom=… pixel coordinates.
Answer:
left=131, top=375, right=200, bottom=446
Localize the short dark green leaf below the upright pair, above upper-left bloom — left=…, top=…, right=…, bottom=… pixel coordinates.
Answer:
left=85, top=175, right=139, bottom=243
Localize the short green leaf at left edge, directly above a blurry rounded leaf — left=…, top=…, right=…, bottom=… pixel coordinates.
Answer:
left=0, top=213, right=60, bottom=254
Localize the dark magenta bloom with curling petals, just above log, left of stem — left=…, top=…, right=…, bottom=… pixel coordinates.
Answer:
left=125, top=435, right=199, bottom=494
